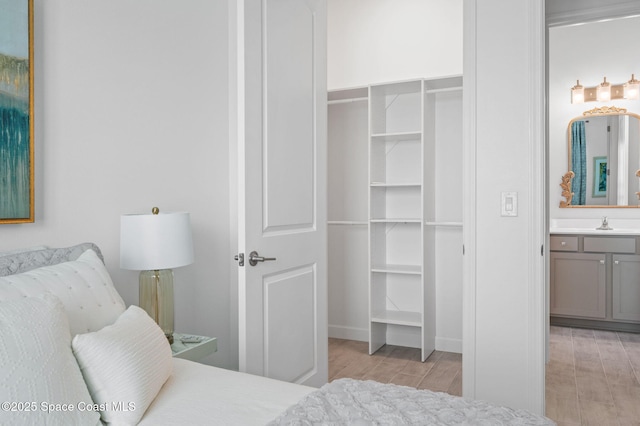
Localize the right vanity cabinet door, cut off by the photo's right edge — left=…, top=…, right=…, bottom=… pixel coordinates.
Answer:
left=613, top=255, right=640, bottom=321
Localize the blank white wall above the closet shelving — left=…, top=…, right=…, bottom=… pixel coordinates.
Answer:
left=327, top=0, right=462, bottom=90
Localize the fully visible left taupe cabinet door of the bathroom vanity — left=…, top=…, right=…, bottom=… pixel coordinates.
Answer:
left=550, top=252, right=606, bottom=319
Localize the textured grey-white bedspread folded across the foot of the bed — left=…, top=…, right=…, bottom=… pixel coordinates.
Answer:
left=269, top=379, right=555, bottom=426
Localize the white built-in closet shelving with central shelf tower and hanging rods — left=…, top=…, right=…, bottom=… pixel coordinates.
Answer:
left=328, top=77, right=462, bottom=361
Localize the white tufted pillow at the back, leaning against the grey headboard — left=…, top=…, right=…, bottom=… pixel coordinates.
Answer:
left=0, top=250, right=126, bottom=336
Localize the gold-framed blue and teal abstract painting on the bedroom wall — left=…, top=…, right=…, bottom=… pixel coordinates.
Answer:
left=0, top=0, right=34, bottom=223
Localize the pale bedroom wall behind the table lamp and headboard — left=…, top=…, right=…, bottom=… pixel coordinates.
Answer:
left=0, top=0, right=237, bottom=367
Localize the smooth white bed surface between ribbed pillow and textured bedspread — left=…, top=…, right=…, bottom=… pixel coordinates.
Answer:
left=139, top=358, right=315, bottom=426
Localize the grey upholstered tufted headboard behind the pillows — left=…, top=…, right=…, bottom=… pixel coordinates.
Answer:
left=0, top=243, right=104, bottom=277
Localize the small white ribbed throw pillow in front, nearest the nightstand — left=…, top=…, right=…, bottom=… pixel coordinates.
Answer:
left=71, top=306, right=173, bottom=424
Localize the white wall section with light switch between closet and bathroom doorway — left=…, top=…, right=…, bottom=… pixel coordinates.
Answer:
left=462, top=0, right=546, bottom=414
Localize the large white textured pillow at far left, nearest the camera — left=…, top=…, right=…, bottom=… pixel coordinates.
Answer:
left=0, top=294, right=100, bottom=425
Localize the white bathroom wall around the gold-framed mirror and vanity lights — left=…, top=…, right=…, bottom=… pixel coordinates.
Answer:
left=548, top=17, right=640, bottom=219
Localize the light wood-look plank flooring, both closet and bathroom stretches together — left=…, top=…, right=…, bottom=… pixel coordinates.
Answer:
left=329, top=327, right=640, bottom=426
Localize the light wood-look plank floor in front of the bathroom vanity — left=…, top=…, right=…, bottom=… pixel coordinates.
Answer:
left=546, top=327, right=640, bottom=426
